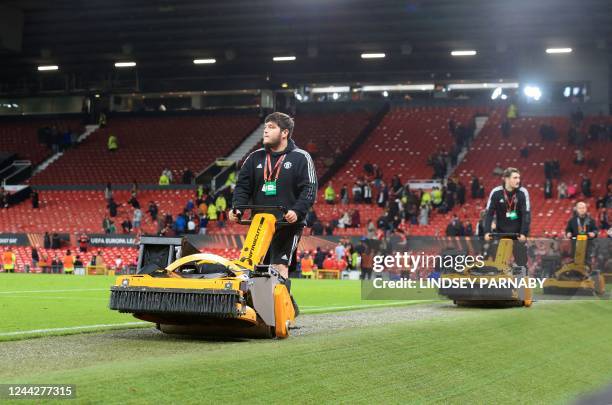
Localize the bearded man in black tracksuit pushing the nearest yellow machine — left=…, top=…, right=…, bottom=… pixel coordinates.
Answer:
left=229, top=112, right=317, bottom=278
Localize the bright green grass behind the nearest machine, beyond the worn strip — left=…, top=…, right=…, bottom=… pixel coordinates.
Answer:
left=0, top=273, right=430, bottom=341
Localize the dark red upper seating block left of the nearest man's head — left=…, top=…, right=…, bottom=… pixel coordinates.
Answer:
left=32, top=114, right=259, bottom=184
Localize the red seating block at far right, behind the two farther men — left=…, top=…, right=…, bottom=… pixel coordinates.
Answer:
left=456, top=112, right=612, bottom=236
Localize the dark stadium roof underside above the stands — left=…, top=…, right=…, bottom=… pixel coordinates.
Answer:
left=0, top=0, right=612, bottom=91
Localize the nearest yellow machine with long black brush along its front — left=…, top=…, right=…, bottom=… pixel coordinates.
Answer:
left=110, top=213, right=296, bottom=338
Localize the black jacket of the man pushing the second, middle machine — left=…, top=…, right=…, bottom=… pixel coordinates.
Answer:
left=484, top=186, right=531, bottom=236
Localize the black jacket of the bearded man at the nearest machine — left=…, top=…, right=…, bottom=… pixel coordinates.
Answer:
left=232, top=139, right=317, bottom=224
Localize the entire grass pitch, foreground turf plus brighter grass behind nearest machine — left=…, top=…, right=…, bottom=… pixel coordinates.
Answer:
left=0, top=275, right=612, bottom=403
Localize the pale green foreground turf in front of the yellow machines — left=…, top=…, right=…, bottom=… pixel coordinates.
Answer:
left=0, top=301, right=612, bottom=404
